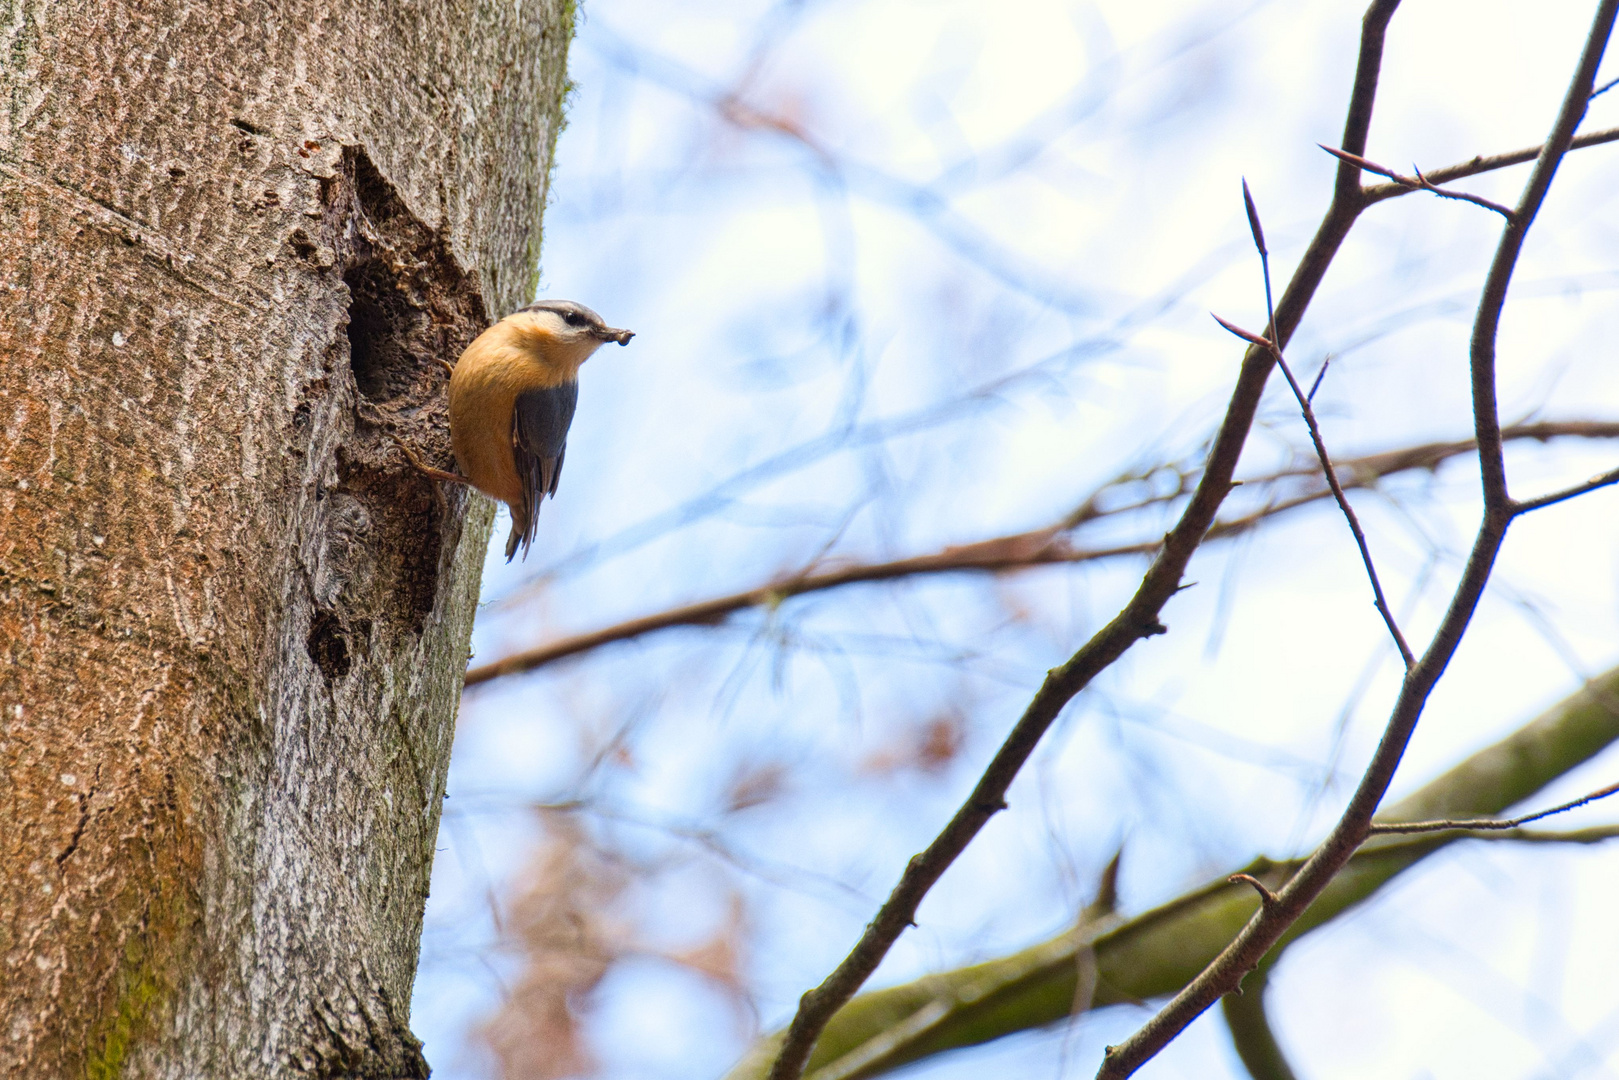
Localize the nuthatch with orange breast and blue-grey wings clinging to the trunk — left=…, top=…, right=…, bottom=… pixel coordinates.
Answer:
left=404, top=300, right=635, bottom=562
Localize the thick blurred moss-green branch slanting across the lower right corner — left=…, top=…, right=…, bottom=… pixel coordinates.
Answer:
left=727, top=669, right=1619, bottom=1080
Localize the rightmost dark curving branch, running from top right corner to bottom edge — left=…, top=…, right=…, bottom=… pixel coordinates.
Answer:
left=1098, top=0, right=1619, bottom=1080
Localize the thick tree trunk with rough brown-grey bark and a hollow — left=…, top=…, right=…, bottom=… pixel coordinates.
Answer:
left=0, top=0, right=573, bottom=1080
